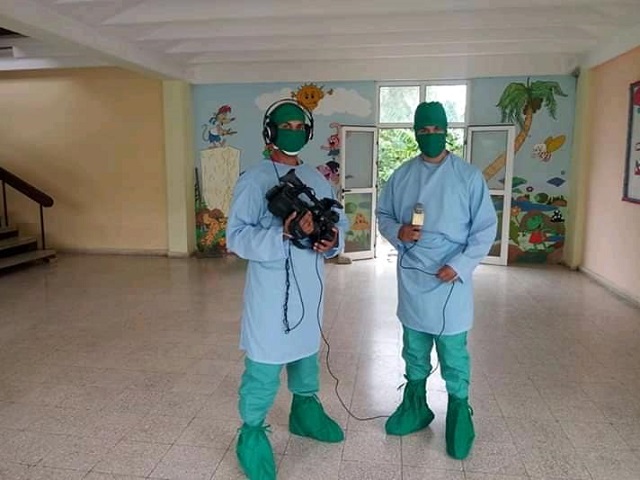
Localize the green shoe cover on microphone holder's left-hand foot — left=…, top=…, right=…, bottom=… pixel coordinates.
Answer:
left=385, top=378, right=434, bottom=436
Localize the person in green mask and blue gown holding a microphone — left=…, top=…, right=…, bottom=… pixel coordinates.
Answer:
left=376, top=102, right=497, bottom=459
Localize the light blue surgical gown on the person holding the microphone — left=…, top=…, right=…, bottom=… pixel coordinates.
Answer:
left=377, top=154, right=497, bottom=335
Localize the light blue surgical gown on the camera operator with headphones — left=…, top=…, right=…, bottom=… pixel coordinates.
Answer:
left=227, top=160, right=347, bottom=364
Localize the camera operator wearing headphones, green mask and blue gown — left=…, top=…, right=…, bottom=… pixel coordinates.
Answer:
left=227, top=100, right=347, bottom=480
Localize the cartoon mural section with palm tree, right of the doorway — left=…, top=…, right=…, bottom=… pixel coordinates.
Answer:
left=471, top=76, right=575, bottom=263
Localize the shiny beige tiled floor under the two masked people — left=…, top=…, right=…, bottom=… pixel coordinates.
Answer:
left=0, top=253, right=640, bottom=480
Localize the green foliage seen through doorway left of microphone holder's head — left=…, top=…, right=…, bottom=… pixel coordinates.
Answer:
left=378, top=128, right=420, bottom=188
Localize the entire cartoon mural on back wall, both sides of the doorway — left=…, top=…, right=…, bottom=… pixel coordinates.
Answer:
left=192, top=75, right=575, bottom=263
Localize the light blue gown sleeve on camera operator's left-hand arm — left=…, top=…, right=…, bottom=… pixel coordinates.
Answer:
left=227, top=174, right=288, bottom=262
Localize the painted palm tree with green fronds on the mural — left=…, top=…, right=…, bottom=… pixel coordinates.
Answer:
left=482, top=79, right=567, bottom=181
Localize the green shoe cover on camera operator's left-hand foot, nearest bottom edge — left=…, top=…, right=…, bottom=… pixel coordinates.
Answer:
left=236, top=424, right=276, bottom=480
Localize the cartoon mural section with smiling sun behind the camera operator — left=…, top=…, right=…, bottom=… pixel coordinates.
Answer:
left=192, top=82, right=375, bottom=256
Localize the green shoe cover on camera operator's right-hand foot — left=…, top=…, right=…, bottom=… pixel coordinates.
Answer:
left=289, top=394, right=344, bottom=443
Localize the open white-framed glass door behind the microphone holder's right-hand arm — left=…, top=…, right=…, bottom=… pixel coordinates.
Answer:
left=466, top=125, right=516, bottom=265
